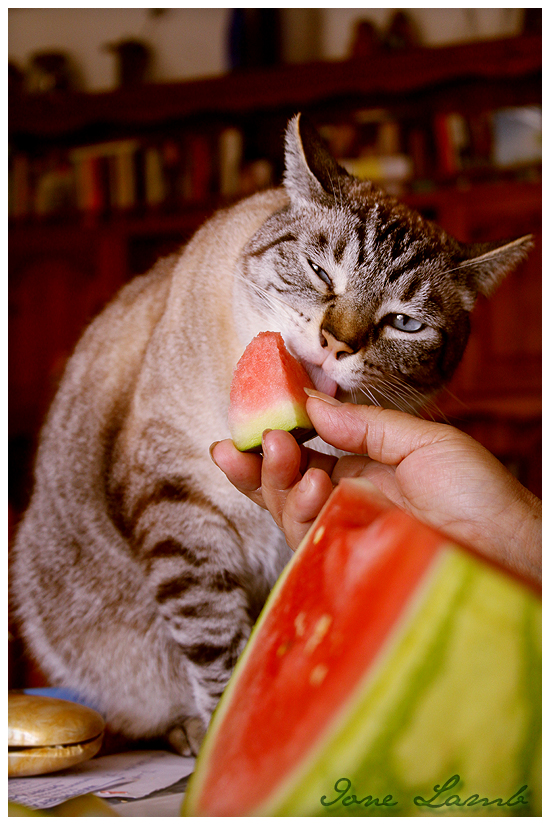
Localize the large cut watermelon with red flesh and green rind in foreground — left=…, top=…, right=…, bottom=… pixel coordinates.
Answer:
left=182, top=479, right=541, bottom=816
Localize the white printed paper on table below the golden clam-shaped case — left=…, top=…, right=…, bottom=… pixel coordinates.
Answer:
left=8, top=751, right=195, bottom=808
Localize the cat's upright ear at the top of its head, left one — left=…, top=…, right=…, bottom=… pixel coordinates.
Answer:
left=284, top=114, right=349, bottom=205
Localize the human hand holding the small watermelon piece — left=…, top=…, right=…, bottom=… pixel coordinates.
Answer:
left=211, top=392, right=542, bottom=582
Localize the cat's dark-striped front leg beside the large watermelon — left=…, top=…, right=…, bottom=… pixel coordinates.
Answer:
left=131, top=484, right=257, bottom=753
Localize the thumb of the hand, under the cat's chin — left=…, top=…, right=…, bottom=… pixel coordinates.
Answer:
left=307, top=393, right=456, bottom=465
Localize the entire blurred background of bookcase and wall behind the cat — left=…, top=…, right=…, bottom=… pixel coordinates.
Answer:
left=8, top=8, right=542, bottom=544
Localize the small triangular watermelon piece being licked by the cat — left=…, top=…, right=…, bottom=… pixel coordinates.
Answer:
left=229, top=332, right=315, bottom=452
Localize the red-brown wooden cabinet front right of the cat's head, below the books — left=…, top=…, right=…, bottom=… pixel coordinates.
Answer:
left=414, top=183, right=542, bottom=496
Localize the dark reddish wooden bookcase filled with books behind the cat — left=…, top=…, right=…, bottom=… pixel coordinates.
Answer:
left=9, top=35, right=542, bottom=512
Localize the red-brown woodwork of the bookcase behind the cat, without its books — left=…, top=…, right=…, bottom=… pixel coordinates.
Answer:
left=9, top=36, right=542, bottom=513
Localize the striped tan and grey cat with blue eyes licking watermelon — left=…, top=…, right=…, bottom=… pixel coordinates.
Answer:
left=13, top=115, right=531, bottom=754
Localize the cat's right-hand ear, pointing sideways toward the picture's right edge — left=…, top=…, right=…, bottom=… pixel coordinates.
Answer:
left=459, top=235, right=533, bottom=303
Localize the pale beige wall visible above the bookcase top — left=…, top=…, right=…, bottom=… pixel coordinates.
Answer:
left=8, top=8, right=523, bottom=91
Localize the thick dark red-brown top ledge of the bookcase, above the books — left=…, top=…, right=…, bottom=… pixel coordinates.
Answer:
left=8, top=35, right=542, bottom=138
